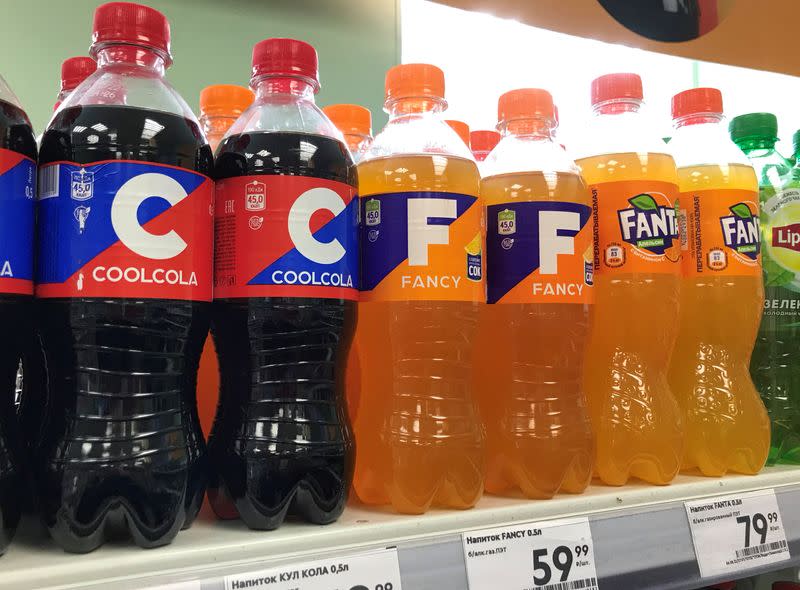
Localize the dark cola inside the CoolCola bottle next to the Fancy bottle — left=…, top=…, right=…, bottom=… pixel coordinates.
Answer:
left=209, top=133, right=357, bottom=529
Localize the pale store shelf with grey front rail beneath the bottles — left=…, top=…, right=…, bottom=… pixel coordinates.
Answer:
left=0, top=467, right=800, bottom=590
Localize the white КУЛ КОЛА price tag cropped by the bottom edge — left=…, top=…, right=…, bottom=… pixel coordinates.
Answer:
left=225, top=549, right=402, bottom=590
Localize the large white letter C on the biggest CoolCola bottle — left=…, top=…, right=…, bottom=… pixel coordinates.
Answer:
left=111, top=173, right=187, bottom=260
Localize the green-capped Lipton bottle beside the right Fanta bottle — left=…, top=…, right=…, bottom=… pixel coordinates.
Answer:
left=730, top=113, right=800, bottom=465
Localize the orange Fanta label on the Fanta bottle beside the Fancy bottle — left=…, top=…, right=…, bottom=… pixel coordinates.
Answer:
left=590, top=180, right=681, bottom=274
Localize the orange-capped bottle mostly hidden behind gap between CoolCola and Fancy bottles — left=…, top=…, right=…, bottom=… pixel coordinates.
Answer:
left=322, top=104, right=372, bottom=423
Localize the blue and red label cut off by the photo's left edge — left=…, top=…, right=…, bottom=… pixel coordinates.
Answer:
left=0, top=148, right=36, bottom=295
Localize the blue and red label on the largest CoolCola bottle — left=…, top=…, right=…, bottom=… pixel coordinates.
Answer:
left=36, top=160, right=213, bottom=301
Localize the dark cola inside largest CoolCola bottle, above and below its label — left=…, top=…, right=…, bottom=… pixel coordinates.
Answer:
left=37, top=106, right=213, bottom=552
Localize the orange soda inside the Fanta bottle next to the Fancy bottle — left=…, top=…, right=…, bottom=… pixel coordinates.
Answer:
left=578, top=152, right=683, bottom=485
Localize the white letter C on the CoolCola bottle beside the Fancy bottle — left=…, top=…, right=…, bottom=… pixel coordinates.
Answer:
left=288, top=187, right=347, bottom=264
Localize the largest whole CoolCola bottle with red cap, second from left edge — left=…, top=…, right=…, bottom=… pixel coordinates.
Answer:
left=36, top=2, right=213, bottom=552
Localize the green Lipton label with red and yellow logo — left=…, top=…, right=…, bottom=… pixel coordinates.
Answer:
left=761, top=189, right=800, bottom=330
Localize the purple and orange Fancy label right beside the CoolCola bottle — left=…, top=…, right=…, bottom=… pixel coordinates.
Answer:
left=360, top=191, right=486, bottom=302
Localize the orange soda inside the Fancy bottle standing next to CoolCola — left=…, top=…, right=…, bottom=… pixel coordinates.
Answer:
left=354, top=155, right=485, bottom=514
